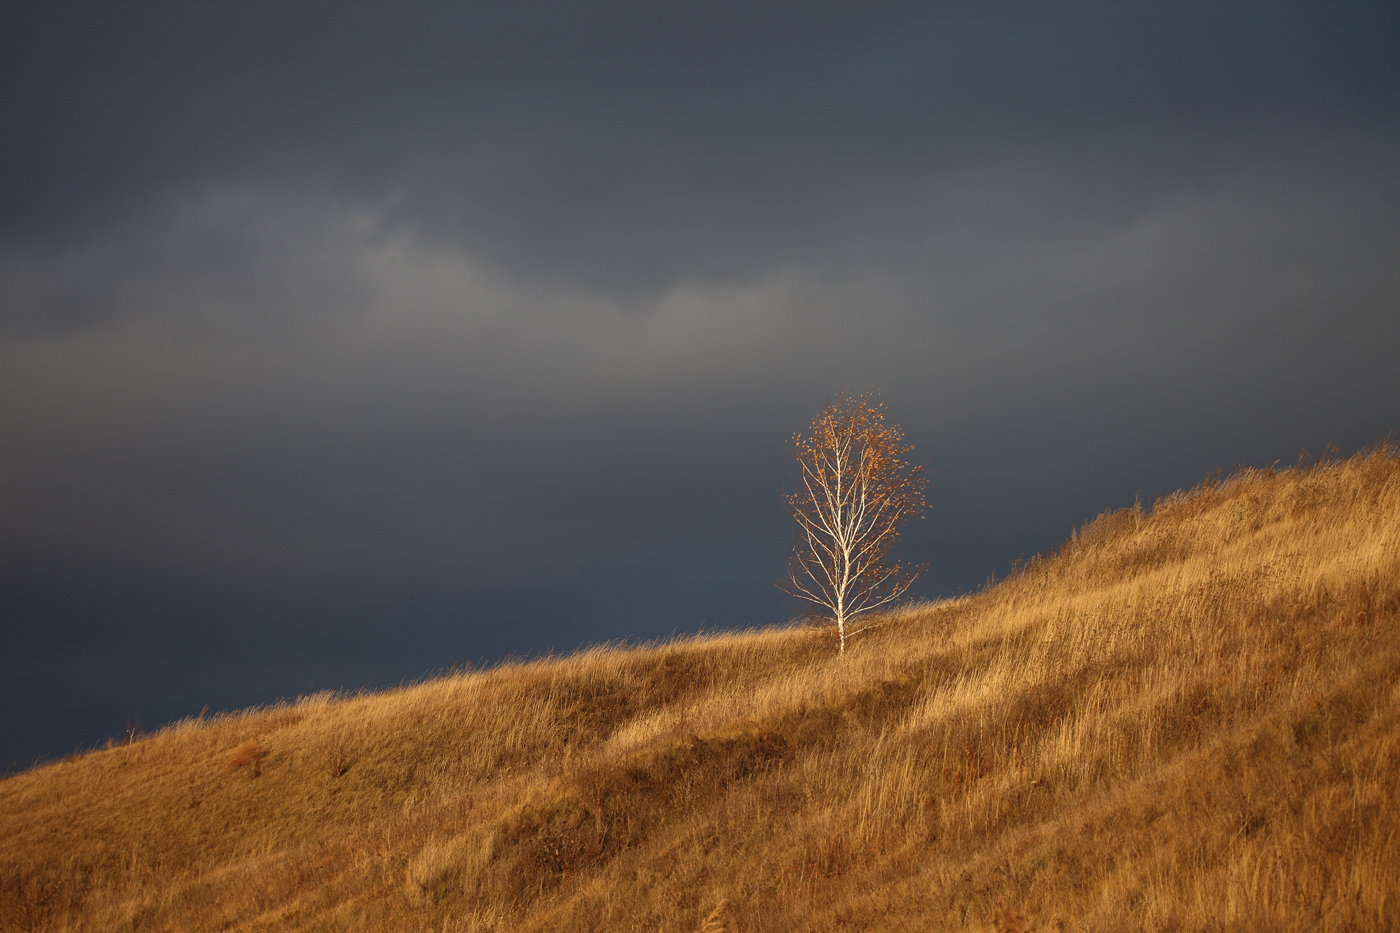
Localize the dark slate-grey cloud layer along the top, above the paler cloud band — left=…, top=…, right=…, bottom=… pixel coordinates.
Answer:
left=0, top=4, right=1400, bottom=290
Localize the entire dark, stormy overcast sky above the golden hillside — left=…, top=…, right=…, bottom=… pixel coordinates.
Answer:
left=0, top=1, right=1400, bottom=769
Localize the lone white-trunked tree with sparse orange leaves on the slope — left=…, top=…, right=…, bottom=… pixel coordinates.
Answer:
left=778, top=392, right=927, bottom=654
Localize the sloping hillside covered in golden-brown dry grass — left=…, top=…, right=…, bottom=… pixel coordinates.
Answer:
left=8, top=448, right=1400, bottom=933
